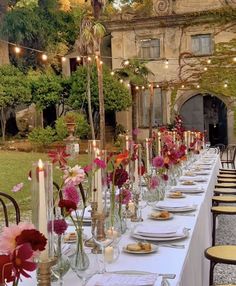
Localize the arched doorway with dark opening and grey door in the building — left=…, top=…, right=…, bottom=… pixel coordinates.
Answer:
left=180, top=94, right=228, bottom=146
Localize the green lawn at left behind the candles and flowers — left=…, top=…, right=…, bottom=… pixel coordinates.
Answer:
left=0, top=151, right=87, bottom=218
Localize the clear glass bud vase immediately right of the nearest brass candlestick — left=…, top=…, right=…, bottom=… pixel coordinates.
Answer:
left=51, top=235, right=70, bottom=286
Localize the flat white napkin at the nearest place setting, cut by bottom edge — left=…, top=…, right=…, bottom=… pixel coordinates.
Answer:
left=87, top=273, right=157, bottom=286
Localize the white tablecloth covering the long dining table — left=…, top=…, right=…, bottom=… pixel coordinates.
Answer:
left=20, top=152, right=220, bottom=286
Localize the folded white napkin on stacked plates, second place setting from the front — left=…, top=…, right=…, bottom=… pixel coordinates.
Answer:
left=135, top=225, right=177, bottom=237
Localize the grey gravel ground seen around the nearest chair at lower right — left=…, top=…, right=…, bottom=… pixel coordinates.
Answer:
left=214, top=215, right=236, bottom=286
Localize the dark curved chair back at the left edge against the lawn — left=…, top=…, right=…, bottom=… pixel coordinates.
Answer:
left=0, top=192, right=20, bottom=226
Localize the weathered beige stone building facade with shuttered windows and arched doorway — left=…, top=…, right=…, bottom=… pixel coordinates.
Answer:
left=106, top=0, right=236, bottom=145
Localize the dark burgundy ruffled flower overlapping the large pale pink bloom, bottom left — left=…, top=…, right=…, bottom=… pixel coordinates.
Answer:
left=16, top=229, right=47, bottom=251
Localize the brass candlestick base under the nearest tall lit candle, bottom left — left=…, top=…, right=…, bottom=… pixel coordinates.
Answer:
left=37, top=258, right=57, bottom=286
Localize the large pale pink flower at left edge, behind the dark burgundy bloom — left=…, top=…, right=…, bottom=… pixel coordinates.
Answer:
left=0, top=222, right=35, bottom=254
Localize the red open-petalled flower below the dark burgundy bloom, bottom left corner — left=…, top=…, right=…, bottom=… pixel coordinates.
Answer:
left=12, top=243, right=37, bottom=278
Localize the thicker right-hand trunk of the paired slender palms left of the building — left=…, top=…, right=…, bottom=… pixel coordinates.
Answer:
left=96, top=56, right=106, bottom=150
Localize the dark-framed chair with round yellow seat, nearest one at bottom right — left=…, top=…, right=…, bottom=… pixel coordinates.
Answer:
left=204, top=245, right=236, bottom=286
